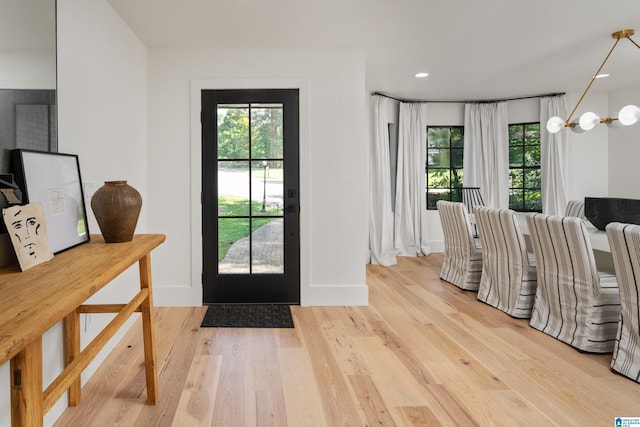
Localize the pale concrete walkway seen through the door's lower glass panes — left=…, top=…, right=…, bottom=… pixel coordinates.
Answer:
left=219, top=218, right=284, bottom=273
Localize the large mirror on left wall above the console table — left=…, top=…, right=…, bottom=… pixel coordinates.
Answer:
left=0, top=0, right=58, bottom=224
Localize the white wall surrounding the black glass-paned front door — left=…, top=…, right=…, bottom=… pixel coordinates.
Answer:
left=148, top=49, right=368, bottom=305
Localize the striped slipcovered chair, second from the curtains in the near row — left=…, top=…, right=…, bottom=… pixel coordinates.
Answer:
left=475, top=207, right=537, bottom=319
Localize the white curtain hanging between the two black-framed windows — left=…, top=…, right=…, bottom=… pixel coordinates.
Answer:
left=463, top=102, right=509, bottom=208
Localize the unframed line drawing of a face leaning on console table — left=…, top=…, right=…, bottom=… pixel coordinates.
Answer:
left=2, top=203, right=53, bottom=271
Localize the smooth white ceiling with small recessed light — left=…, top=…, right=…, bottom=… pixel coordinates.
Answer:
left=109, top=0, right=640, bottom=100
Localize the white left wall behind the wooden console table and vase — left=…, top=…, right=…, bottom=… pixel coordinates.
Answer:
left=0, top=0, right=149, bottom=426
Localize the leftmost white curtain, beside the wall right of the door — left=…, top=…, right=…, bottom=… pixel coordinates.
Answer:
left=369, top=95, right=397, bottom=266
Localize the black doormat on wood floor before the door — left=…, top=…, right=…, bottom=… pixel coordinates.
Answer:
left=200, top=304, right=293, bottom=328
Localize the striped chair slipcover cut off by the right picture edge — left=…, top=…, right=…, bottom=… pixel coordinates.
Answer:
left=607, top=222, right=640, bottom=382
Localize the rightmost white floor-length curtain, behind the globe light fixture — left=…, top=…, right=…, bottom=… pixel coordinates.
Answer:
left=540, top=95, right=569, bottom=215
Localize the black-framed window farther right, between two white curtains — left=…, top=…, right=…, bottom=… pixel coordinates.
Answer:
left=509, top=123, right=542, bottom=212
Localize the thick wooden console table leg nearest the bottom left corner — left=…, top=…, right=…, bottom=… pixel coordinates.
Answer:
left=10, top=337, right=44, bottom=426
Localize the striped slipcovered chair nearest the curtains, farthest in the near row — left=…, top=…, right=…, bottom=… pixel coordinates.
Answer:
left=436, top=200, right=482, bottom=291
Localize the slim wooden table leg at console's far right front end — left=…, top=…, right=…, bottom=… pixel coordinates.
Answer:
left=139, top=254, right=158, bottom=405
